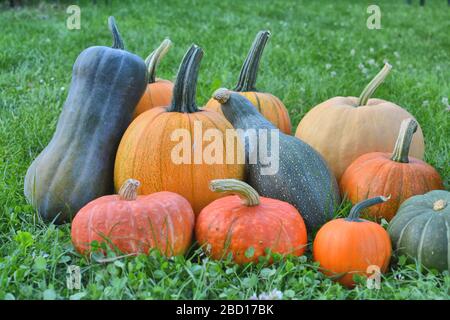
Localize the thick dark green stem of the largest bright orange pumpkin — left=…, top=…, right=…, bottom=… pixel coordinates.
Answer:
left=167, top=44, right=203, bottom=113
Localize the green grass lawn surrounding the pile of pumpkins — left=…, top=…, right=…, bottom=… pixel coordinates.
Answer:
left=0, top=0, right=450, bottom=299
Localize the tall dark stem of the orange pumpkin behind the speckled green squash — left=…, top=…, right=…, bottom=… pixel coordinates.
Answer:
left=234, top=31, right=270, bottom=92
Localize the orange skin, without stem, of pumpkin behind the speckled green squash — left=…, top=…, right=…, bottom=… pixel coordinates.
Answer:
left=205, top=92, right=292, bottom=134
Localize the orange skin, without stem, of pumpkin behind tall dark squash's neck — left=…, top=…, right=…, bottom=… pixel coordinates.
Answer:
left=133, top=79, right=173, bottom=119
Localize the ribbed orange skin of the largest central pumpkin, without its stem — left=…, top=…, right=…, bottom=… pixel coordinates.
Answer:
left=115, top=107, right=244, bottom=214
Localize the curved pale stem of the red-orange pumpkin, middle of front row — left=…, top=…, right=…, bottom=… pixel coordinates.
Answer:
left=209, top=179, right=259, bottom=207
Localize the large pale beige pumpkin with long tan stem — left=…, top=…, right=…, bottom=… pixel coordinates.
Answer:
left=295, top=64, right=424, bottom=181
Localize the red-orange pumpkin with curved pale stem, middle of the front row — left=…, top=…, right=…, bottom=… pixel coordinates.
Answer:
left=195, top=179, right=307, bottom=264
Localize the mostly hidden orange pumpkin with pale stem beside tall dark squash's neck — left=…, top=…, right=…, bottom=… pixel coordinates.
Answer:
left=133, top=39, right=173, bottom=118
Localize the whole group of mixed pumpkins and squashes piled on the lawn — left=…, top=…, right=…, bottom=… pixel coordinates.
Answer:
left=24, top=17, right=450, bottom=286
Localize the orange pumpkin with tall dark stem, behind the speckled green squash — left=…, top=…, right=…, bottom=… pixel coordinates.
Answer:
left=205, top=31, right=292, bottom=134
